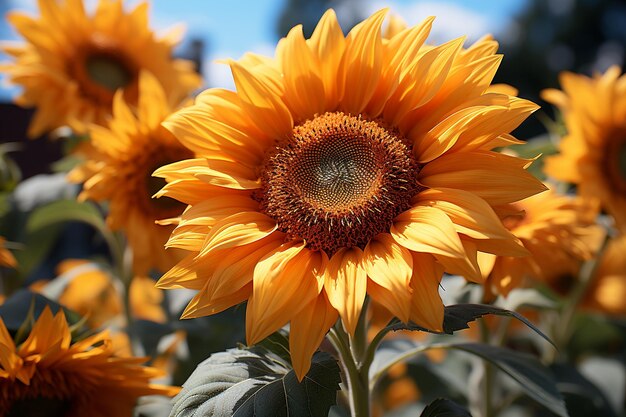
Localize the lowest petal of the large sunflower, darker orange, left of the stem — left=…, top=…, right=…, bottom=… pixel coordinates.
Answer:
left=289, top=291, right=338, bottom=381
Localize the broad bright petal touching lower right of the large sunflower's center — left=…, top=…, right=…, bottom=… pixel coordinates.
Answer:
left=391, top=206, right=465, bottom=258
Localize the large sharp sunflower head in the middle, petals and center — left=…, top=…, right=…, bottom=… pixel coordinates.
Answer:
left=155, top=10, right=544, bottom=377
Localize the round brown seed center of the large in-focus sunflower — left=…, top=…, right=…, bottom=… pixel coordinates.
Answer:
left=256, top=112, right=421, bottom=256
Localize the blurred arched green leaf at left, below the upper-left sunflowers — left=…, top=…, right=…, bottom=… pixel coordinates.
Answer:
left=26, top=200, right=108, bottom=233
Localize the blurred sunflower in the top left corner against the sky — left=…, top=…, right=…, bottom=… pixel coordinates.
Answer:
left=0, top=0, right=200, bottom=137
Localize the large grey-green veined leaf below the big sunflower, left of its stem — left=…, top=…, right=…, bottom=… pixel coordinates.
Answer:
left=170, top=347, right=341, bottom=417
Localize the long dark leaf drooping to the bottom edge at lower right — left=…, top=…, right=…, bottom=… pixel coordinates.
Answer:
left=448, top=343, right=569, bottom=417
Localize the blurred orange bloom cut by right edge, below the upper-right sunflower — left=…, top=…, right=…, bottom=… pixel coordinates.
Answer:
left=583, top=235, right=626, bottom=317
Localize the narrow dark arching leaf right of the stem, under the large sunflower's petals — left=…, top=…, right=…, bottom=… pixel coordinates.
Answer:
left=385, top=304, right=554, bottom=346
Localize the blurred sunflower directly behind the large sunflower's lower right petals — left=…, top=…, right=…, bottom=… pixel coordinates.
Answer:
left=480, top=185, right=604, bottom=295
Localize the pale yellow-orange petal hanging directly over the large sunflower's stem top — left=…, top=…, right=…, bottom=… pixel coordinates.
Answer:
left=324, top=247, right=367, bottom=335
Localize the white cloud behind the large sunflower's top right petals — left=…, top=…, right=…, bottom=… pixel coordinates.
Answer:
left=368, top=1, right=498, bottom=44
